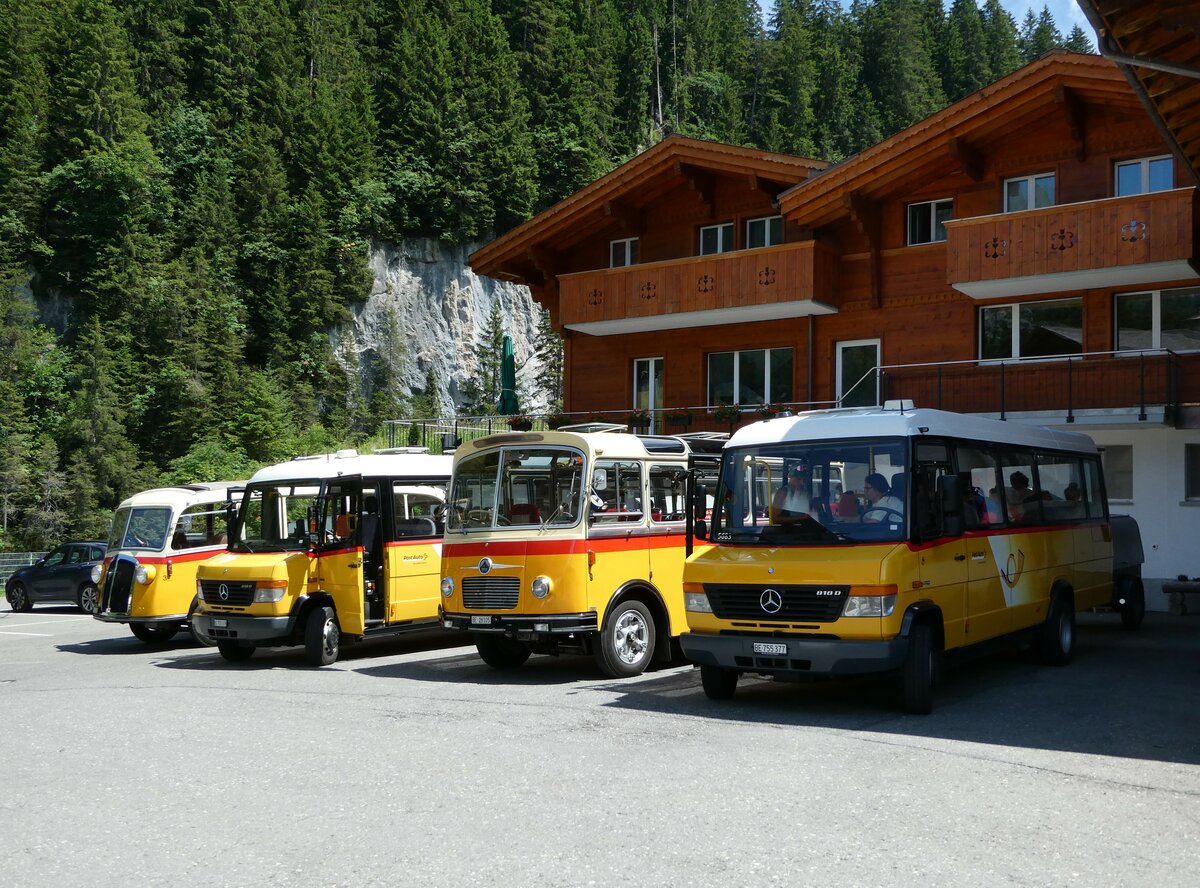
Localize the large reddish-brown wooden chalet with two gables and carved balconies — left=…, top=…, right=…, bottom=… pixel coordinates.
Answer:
left=472, top=52, right=1200, bottom=606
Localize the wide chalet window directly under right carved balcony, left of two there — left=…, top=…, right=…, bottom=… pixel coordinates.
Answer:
left=979, top=299, right=1084, bottom=361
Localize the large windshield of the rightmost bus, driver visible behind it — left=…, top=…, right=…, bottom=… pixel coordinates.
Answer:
left=713, top=438, right=908, bottom=546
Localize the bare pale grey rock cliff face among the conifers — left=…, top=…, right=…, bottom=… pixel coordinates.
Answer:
left=332, top=239, right=546, bottom=415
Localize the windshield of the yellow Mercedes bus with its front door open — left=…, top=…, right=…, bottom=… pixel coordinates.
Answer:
left=229, top=479, right=322, bottom=552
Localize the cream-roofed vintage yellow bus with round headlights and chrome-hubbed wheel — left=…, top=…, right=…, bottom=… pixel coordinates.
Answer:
left=442, top=427, right=724, bottom=677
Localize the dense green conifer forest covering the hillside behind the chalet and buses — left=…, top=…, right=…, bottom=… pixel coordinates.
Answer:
left=0, top=0, right=1091, bottom=548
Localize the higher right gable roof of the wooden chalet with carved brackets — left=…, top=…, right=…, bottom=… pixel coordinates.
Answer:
left=779, top=49, right=1140, bottom=228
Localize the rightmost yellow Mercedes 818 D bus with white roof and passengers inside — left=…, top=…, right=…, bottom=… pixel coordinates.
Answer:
left=680, top=402, right=1145, bottom=712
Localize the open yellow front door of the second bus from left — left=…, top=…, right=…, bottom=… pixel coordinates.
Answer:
left=317, top=476, right=364, bottom=635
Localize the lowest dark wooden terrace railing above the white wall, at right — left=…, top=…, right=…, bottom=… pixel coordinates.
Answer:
left=880, top=350, right=1200, bottom=422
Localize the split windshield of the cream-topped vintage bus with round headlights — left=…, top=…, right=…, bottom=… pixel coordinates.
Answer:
left=448, top=448, right=583, bottom=533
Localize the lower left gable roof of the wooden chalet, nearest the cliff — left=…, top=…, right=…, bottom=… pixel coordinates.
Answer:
left=470, top=136, right=828, bottom=283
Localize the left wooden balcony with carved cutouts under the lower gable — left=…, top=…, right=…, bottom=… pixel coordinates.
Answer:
left=558, top=241, right=836, bottom=336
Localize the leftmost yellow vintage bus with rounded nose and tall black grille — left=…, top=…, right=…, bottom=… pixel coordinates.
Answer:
left=92, top=481, right=245, bottom=644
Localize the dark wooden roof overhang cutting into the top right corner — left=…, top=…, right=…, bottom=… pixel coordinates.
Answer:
left=1079, top=0, right=1200, bottom=185
